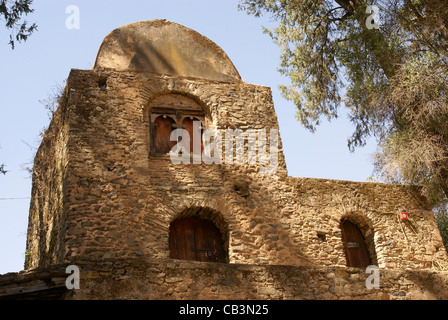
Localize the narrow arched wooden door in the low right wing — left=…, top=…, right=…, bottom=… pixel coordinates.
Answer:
left=341, top=220, right=370, bottom=268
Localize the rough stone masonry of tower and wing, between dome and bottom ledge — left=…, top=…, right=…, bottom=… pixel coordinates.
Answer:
left=27, top=70, right=447, bottom=270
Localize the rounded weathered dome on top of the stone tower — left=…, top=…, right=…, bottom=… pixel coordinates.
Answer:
left=94, top=20, right=241, bottom=81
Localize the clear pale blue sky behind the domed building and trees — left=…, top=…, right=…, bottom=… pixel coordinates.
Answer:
left=0, top=0, right=375, bottom=274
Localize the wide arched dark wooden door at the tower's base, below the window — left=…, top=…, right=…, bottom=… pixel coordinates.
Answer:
left=169, top=217, right=226, bottom=262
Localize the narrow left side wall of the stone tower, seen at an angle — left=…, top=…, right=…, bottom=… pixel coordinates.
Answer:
left=25, top=91, right=70, bottom=269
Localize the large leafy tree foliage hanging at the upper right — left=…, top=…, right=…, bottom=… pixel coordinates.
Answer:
left=240, top=0, right=448, bottom=210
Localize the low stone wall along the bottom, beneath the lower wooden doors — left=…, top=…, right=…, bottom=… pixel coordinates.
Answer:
left=0, top=257, right=448, bottom=300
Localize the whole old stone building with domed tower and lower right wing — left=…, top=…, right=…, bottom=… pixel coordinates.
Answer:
left=0, top=20, right=448, bottom=300
